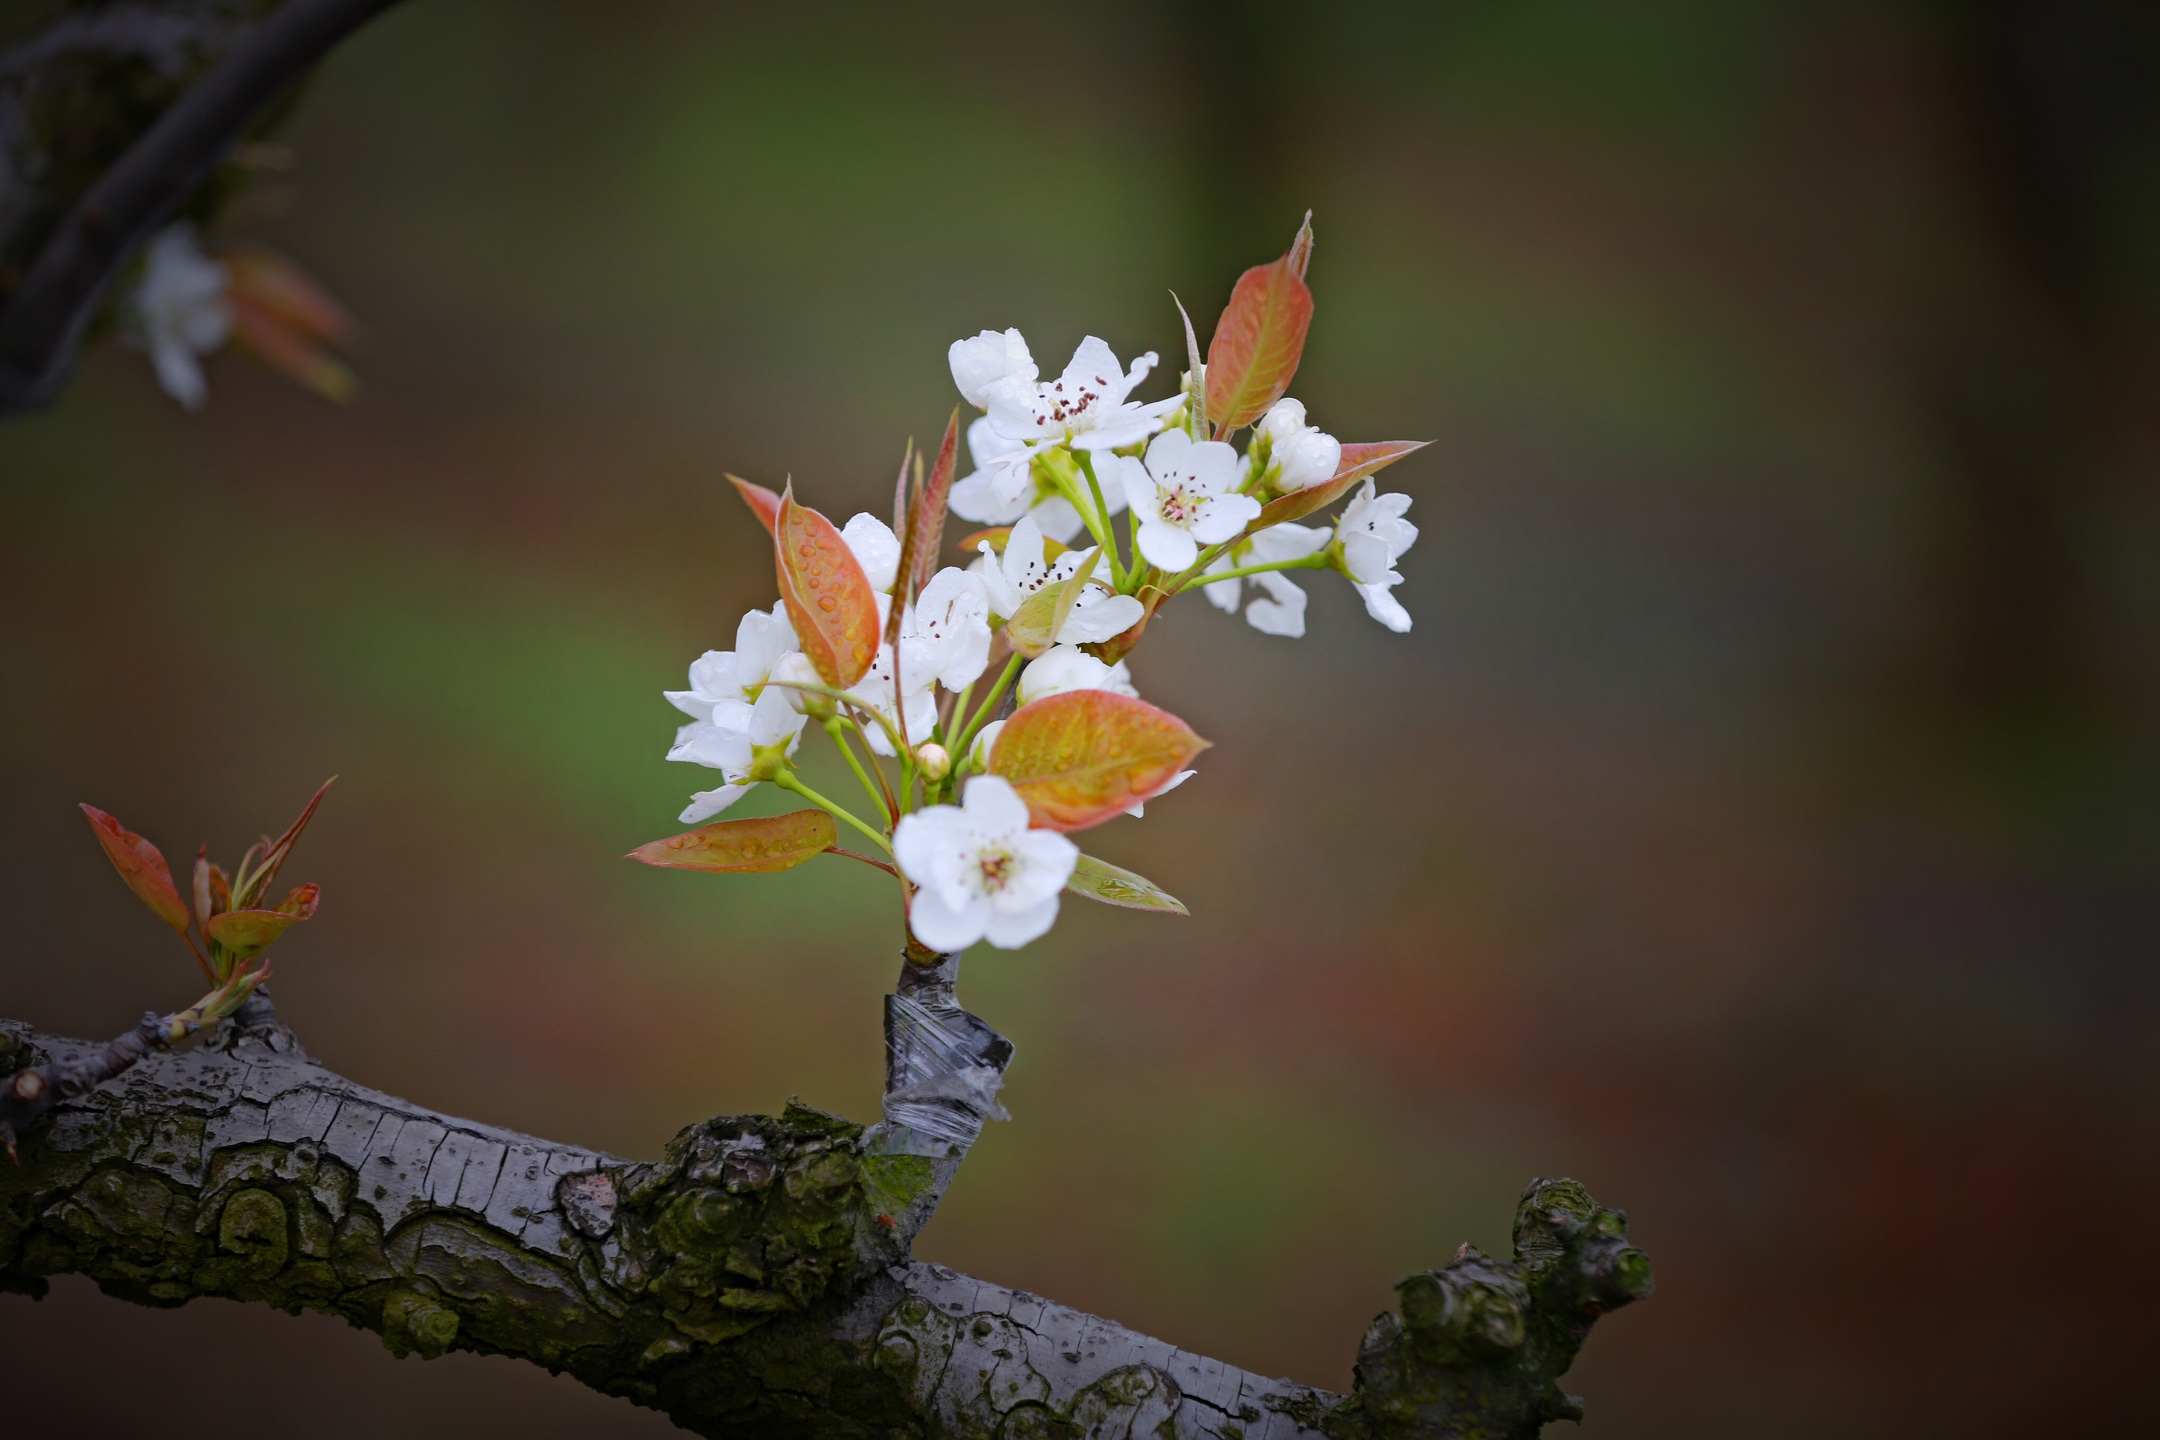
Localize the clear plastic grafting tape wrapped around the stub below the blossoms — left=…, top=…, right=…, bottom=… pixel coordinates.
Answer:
left=883, top=989, right=1013, bottom=1159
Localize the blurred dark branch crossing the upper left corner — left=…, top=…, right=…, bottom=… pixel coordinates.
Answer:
left=0, top=0, right=395, bottom=419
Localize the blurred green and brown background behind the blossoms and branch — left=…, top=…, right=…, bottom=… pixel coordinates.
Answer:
left=0, top=0, right=2160, bottom=1440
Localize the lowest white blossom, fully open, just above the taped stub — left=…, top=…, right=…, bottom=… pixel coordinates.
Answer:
left=892, top=775, right=1080, bottom=954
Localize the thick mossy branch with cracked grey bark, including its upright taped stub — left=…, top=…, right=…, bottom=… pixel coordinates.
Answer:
left=0, top=959, right=1650, bottom=1440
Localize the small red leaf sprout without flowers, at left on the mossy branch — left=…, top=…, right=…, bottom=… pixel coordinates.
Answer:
left=82, top=777, right=335, bottom=1043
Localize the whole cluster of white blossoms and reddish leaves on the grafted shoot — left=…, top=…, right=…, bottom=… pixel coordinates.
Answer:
left=631, top=216, right=1423, bottom=954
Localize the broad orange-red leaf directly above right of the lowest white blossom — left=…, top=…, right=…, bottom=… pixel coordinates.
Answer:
left=989, top=691, right=1207, bottom=831
